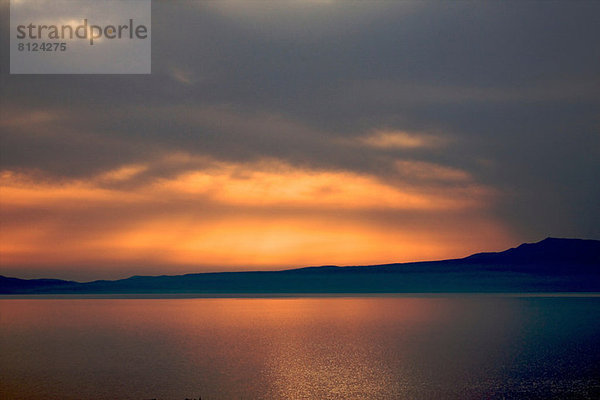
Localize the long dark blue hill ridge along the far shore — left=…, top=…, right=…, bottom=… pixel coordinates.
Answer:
left=0, top=238, right=600, bottom=295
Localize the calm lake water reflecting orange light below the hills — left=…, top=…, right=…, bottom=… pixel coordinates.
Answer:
left=0, top=296, right=600, bottom=400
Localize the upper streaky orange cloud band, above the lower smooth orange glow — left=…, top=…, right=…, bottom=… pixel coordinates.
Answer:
left=1, top=154, right=491, bottom=211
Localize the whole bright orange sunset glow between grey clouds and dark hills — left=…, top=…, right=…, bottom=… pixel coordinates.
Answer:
left=0, top=157, right=511, bottom=278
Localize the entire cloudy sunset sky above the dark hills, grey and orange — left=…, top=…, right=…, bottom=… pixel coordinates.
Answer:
left=0, top=0, right=600, bottom=281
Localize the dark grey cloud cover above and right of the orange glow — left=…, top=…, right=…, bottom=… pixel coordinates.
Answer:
left=0, top=1, right=600, bottom=240
